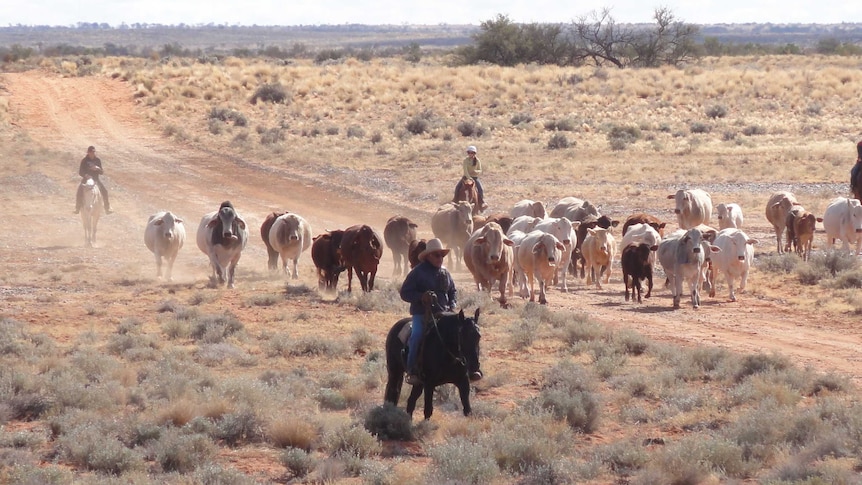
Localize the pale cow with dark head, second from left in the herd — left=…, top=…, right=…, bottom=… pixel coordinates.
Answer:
left=197, top=201, right=248, bottom=288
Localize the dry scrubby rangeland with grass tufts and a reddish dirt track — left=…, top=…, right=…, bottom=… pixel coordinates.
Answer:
left=0, top=56, right=862, bottom=484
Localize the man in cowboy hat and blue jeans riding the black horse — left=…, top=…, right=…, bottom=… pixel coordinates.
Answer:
left=401, top=238, right=458, bottom=385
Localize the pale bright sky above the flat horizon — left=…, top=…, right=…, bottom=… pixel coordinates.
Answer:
left=0, top=0, right=862, bottom=27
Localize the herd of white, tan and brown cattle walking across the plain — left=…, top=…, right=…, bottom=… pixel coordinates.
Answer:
left=132, top=189, right=862, bottom=308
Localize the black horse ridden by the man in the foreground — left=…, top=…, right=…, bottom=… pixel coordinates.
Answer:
left=384, top=308, right=482, bottom=419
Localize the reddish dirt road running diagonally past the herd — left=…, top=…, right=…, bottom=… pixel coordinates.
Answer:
left=0, top=72, right=862, bottom=382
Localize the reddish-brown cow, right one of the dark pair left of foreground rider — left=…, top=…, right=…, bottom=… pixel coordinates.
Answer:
left=341, top=224, right=383, bottom=292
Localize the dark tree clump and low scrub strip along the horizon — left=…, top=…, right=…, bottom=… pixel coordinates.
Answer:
left=0, top=7, right=862, bottom=68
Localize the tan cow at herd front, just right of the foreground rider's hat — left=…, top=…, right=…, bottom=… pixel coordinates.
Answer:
left=464, top=222, right=514, bottom=307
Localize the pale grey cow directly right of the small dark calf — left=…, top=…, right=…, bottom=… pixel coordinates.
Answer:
left=658, top=228, right=721, bottom=309
